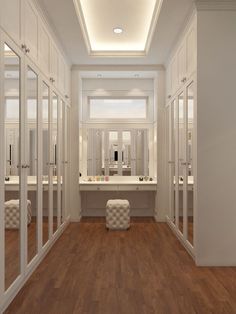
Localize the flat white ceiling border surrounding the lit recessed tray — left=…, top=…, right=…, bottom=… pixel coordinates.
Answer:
left=37, top=0, right=193, bottom=65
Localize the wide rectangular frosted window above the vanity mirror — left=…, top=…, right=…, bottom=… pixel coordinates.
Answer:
left=89, top=98, right=147, bottom=119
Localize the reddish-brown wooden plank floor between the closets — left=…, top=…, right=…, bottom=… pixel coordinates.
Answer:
left=6, top=219, right=236, bottom=314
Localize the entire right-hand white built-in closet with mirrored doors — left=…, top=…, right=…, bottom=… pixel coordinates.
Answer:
left=166, top=13, right=197, bottom=256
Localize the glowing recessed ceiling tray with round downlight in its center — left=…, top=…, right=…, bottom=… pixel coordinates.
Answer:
left=73, top=0, right=162, bottom=56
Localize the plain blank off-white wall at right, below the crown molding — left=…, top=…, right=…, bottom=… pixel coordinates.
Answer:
left=195, top=11, right=236, bottom=266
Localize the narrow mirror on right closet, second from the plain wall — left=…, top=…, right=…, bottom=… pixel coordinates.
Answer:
left=178, top=93, right=185, bottom=233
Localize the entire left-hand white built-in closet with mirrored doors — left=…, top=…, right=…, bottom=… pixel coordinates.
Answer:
left=0, top=0, right=70, bottom=312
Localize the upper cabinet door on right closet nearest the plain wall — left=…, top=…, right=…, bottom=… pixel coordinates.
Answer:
left=186, top=24, right=197, bottom=77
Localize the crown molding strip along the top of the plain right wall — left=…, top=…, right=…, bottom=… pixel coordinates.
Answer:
left=194, top=0, right=236, bottom=11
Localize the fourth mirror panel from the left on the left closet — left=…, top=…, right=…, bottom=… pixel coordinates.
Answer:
left=52, top=93, right=58, bottom=233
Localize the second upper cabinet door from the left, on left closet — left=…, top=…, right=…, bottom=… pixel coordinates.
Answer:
left=23, top=0, right=38, bottom=63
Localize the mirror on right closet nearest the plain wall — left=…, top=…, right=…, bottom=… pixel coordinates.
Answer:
left=187, top=82, right=194, bottom=245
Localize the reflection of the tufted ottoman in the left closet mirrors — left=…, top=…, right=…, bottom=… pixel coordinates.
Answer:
left=5, top=200, right=32, bottom=229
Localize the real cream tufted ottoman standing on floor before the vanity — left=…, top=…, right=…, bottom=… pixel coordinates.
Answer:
left=106, top=199, right=130, bottom=229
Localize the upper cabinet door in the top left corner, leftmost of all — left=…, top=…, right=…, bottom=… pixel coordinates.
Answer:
left=0, top=0, right=22, bottom=46
